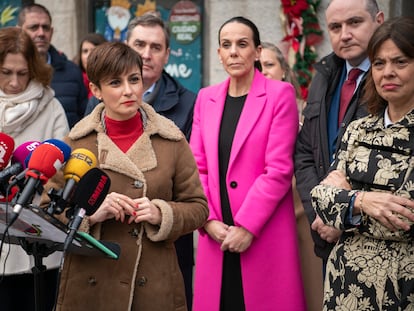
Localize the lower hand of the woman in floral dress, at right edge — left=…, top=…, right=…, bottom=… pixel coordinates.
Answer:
left=356, top=191, right=414, bottom=231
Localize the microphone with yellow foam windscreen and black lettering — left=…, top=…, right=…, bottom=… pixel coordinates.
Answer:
left=47, top=148, right=97, bottom=215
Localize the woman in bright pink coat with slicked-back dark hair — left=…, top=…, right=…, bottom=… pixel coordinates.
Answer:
left=190, top=17, right=306, bottom=311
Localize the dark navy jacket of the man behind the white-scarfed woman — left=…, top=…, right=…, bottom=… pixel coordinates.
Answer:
left=49, top=45, right=88, bottom=128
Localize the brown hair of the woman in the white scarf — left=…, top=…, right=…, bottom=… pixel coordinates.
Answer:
left=0, top=27, right=52, bottom=86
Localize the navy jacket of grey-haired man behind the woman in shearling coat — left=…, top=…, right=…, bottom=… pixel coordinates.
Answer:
left=85, top=71, right=197, bottom=140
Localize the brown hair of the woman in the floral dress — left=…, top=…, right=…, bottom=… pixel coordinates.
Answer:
left=363, top=16, right=414, bottom=114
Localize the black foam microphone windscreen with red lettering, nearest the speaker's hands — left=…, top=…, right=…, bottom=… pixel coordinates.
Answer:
left=72, top=167, right=111, bottom=216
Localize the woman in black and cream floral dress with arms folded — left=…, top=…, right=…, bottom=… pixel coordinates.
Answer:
left=311, top=17, right=414, bottom=311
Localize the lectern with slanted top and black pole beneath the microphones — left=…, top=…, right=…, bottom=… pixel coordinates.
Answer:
left=0, top=203, right=121, bottom=311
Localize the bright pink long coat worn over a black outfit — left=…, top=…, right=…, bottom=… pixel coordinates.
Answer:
left=190, top=70, right=306, bottom=311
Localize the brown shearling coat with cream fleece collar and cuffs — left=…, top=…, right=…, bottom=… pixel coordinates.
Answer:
left=57, top=104, right=208, bottom=311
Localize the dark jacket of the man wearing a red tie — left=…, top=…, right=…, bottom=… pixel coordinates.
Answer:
left=295, top=53, right=367, bottom=259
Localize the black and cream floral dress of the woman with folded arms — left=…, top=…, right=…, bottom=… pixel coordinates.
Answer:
left=311, top=111, right=414, bottom=311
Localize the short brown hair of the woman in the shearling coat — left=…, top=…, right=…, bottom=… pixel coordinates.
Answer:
left=86, top=42, right=142, bottom=88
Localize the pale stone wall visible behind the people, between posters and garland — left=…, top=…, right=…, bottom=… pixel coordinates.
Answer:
left=36, top=0, right=393, bottom=85
